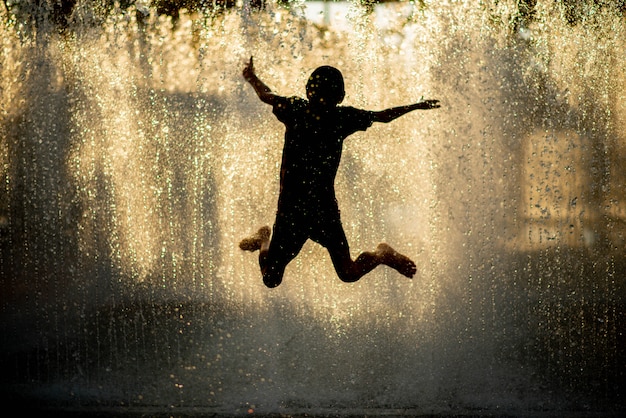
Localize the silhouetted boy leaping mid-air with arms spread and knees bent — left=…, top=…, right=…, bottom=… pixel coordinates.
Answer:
left=239, top=57, right=439, bottom=287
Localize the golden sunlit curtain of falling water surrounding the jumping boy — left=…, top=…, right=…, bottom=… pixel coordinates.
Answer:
left=0, top=2, right=626, bottom=415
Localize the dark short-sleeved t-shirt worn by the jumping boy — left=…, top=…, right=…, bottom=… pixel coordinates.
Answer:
left=273, top=97, right=373, bottom=211
